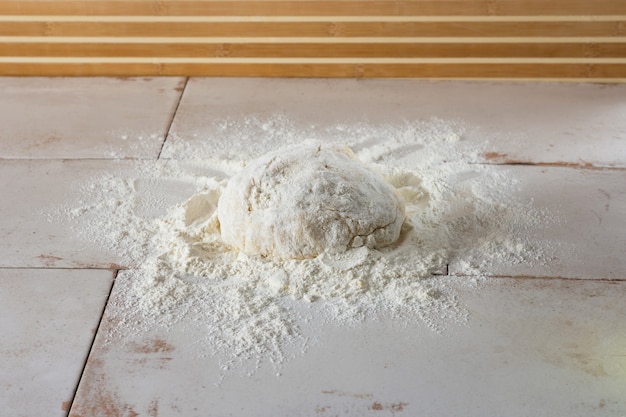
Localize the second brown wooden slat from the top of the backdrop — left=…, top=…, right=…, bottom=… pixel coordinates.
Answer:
left=0, top=20, right=626, bottom=38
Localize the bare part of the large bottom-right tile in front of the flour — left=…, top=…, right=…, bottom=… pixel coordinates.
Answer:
left=70, top=274, right=626, bottom=417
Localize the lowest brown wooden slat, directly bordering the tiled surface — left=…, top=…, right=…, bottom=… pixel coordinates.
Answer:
left=0, top=62, right=626, bottom=82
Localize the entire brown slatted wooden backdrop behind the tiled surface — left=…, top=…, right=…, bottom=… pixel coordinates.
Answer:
left=0, top=0, right=626, bottom=82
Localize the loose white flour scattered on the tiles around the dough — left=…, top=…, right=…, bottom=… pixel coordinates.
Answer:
left=53, top=116, right=549, bottom=380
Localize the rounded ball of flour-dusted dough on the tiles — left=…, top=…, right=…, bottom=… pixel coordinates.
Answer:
left=218, top=146, right=405, bottom=260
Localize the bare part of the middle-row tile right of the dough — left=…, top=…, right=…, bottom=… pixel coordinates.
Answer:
left=449, top=166, right=626, bottom=279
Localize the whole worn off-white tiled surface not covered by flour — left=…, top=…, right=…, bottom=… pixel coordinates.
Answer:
left=0, top=78, right=626, bottom=417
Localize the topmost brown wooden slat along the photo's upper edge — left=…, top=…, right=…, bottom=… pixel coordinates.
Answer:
left=0, top=0, right=624, bottom=16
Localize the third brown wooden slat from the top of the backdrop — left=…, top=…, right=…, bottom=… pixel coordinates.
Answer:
left=0, top=41, right=626, bottom=58
